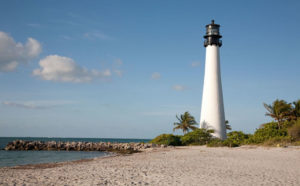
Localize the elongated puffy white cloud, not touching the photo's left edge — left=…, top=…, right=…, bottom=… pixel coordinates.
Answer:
left=32, top=55, right=112, bottom=83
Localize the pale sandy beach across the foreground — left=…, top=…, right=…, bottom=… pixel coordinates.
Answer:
left=0, top=147, right=300, bottom=186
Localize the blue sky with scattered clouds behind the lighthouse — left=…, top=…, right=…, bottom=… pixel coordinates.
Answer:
left=0, top=0, right=300, bottom=138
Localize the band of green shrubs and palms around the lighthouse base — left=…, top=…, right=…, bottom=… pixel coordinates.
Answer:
left=151, top=100, right=300, bottom=147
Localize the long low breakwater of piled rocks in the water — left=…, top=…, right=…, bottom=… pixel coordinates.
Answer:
left=4, top=140, right=167, bottom=154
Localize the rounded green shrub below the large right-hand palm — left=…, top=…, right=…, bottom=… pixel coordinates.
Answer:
left=247, top=122, right=287, bottom=144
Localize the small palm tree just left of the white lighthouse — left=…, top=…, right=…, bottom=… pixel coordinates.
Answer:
left=173, top=112, right=198, bottom=134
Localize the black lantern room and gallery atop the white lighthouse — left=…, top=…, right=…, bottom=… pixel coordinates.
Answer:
left=204, top=20, right=222, bottom=47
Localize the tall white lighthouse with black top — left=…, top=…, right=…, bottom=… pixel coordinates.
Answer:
left=200, top=20, right=226, bottom=139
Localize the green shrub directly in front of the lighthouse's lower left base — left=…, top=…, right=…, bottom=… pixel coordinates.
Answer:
left=181, top=129, right=213, bottom=145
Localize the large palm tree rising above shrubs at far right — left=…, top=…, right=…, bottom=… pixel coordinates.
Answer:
left=264, top=99, right=292, bottom=129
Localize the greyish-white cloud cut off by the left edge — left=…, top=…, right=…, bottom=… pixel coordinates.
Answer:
left=0, top=31, right=42, bottom=72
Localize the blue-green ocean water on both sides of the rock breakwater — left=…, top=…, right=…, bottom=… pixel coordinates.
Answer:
left=0, top=137, right=150, bottom=167
